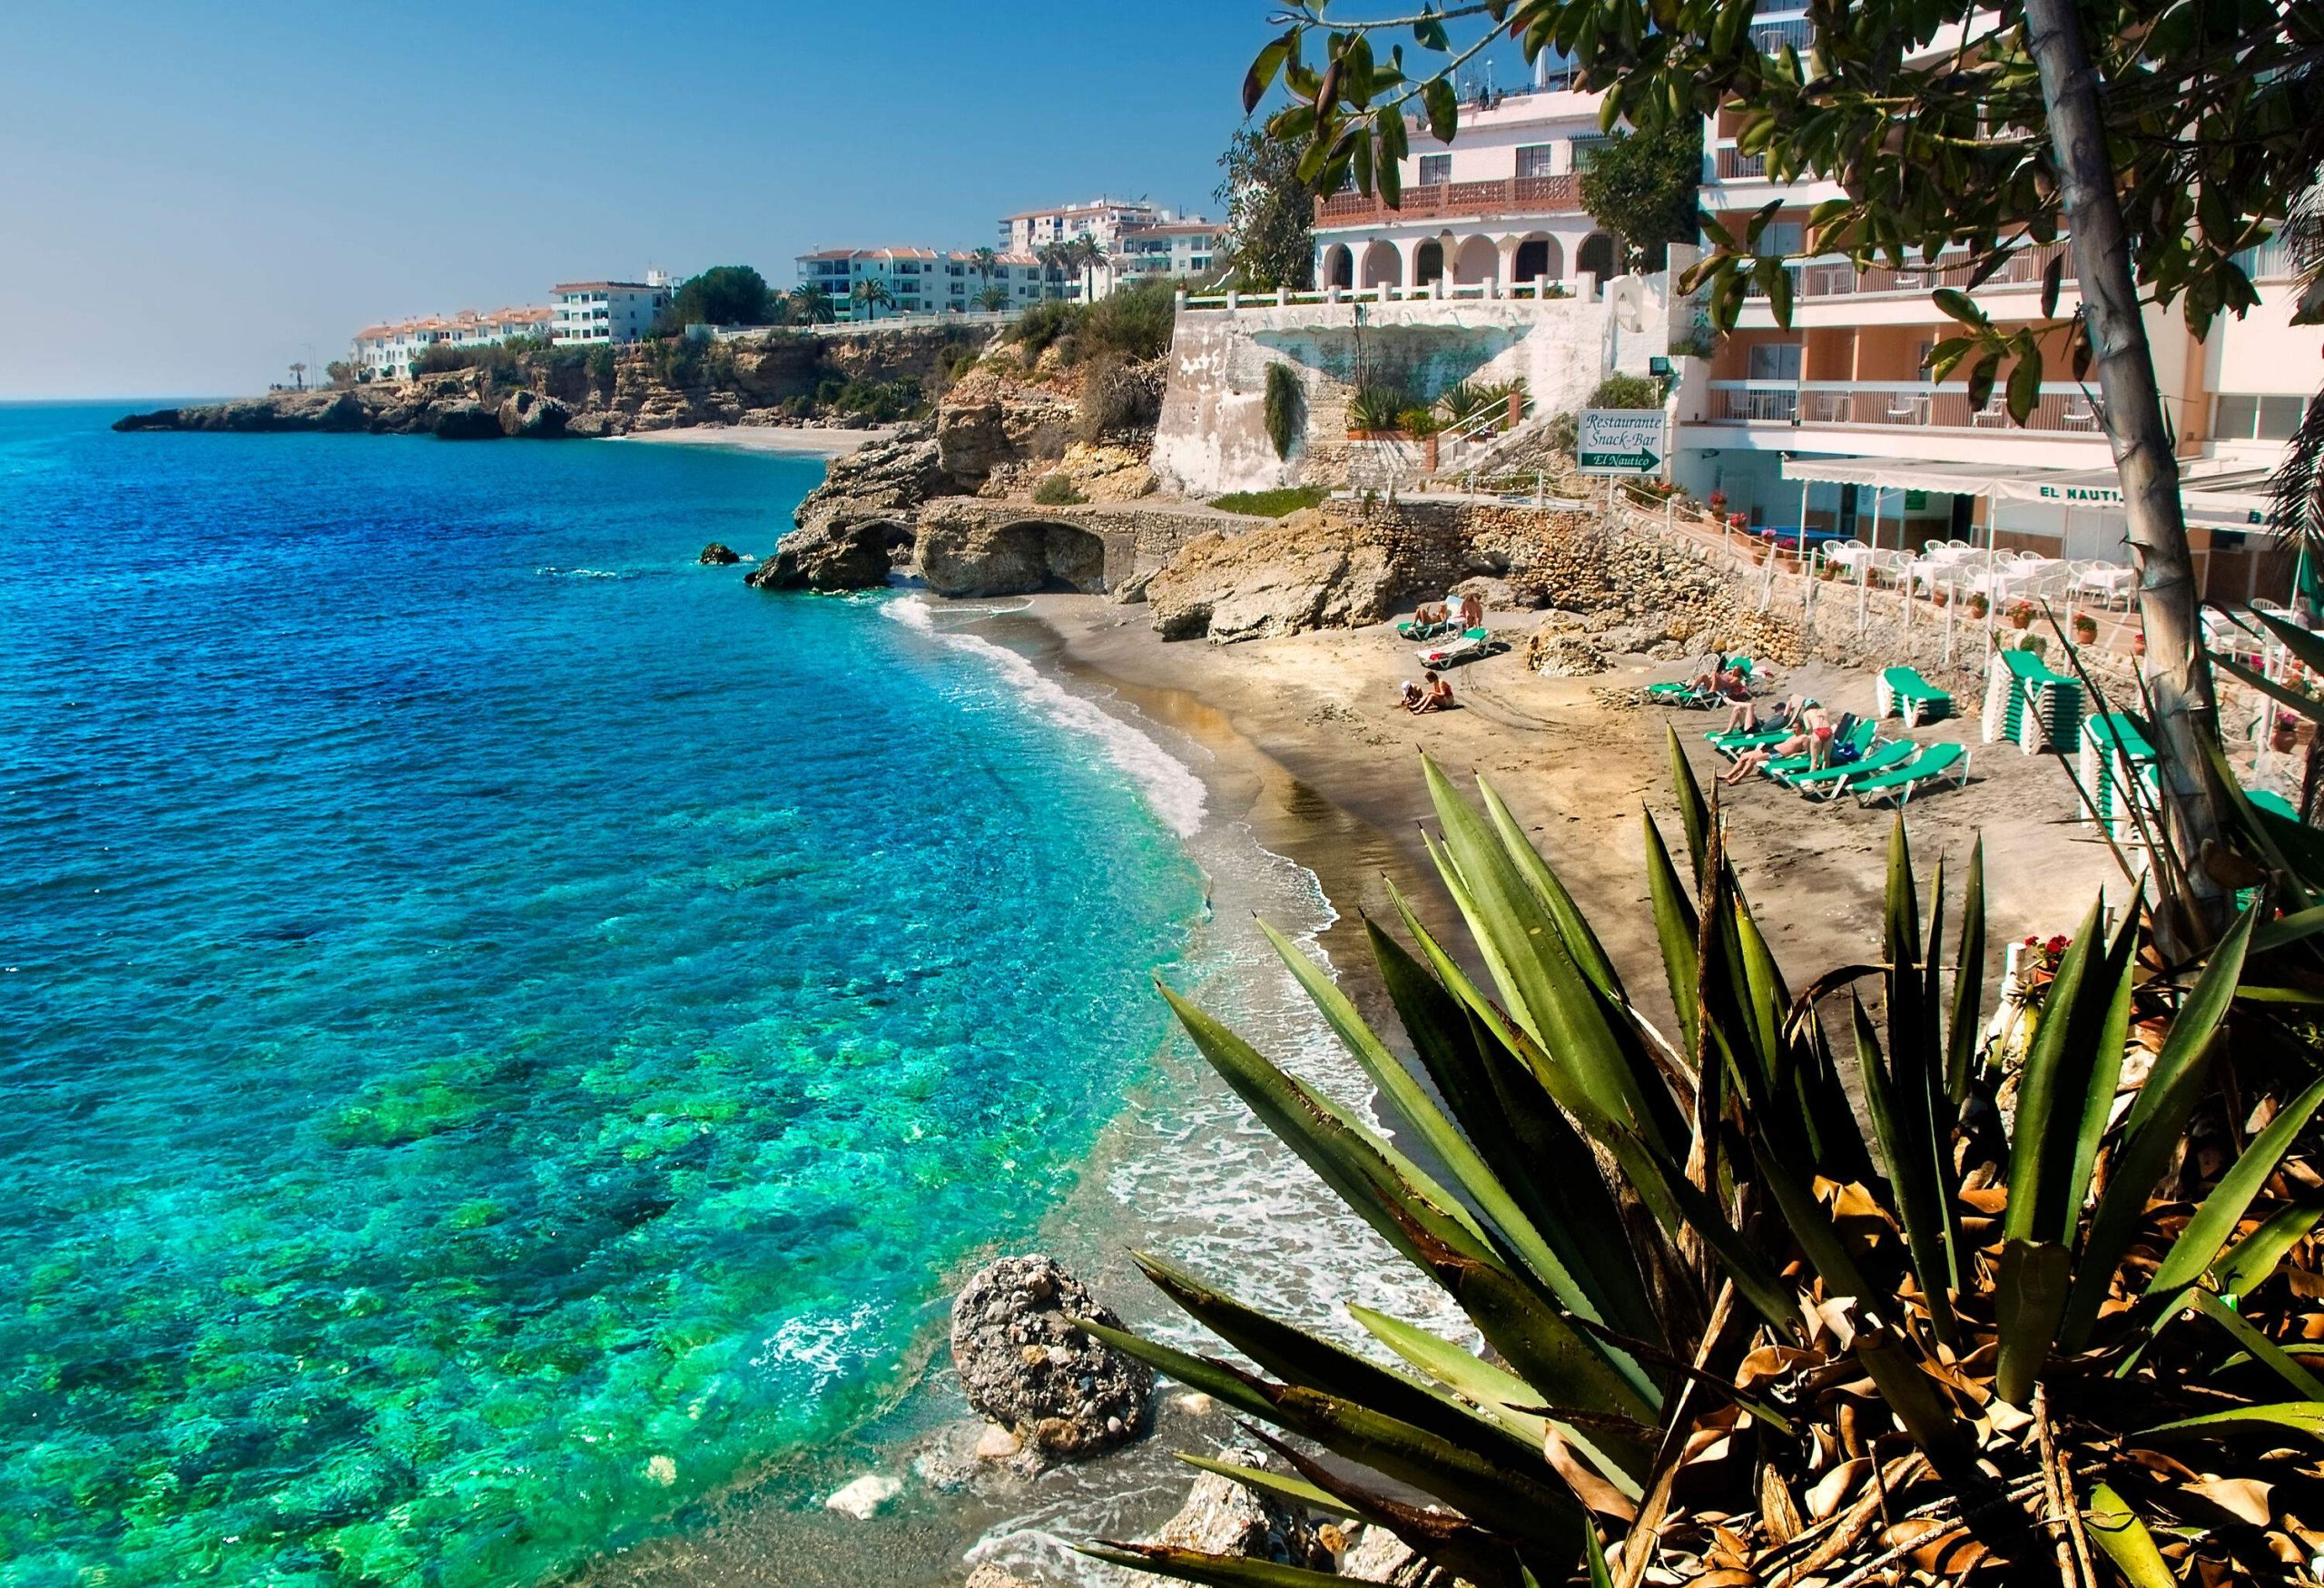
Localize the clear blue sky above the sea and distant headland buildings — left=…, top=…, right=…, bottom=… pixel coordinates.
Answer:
left=0, top=0, right=1274, bottom=398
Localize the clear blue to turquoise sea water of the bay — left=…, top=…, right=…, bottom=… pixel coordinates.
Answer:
left=0, top=407, right=1202, bottom=1588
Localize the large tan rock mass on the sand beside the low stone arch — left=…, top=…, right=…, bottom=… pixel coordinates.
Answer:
left=1146, top=509, right=1402, bottom=644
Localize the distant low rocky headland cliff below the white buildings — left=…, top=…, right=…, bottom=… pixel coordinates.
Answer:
left=113, top=326, right=985, bottom=439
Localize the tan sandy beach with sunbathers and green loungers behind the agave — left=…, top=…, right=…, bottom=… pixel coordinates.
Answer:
left=1028, top=596, right=2124, bottom=998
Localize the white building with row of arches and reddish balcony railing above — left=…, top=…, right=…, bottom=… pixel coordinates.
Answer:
left=1315, top=51, right=1622, bottom=295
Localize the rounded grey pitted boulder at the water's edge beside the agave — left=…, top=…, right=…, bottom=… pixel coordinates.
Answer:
left=953, top=1256, right=1155, bottom=1458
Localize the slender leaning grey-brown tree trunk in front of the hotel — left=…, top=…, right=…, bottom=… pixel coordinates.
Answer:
left=2026, top=0, right=2229, bottom=961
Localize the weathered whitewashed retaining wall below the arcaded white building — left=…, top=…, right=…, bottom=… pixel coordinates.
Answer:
left=1153, top=277, right=1669, bottom=498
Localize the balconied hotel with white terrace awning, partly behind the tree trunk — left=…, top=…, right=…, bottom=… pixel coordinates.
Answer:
left=1673, top=0, right=2324, bottom=600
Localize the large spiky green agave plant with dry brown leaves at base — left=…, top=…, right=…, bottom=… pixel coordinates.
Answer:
left=1086, top=737, right=2324, bottom=1588
